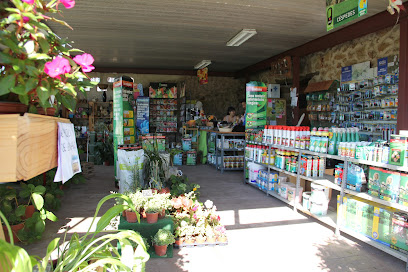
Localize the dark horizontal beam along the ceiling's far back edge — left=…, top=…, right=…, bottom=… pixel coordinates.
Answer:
left=92, top=67, right=235, bottom=77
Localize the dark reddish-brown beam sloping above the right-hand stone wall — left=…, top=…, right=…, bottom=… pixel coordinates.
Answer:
left=236, top=3, right=408, bottom=77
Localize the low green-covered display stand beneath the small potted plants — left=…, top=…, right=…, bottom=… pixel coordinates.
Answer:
left=118, top=216, right=174, bottom=258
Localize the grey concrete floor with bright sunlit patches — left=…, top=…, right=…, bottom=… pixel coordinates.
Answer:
left=23, top=165, right=405, bottom=272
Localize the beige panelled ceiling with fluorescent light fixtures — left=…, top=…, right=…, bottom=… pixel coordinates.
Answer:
left=50, top=0, right=394, bottom=72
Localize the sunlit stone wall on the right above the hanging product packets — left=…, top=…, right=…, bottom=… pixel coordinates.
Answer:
left=300, top=25, right=400, bottom=82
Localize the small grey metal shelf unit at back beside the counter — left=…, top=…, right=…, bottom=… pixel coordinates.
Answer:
left=210, top=131, right=245, bottom=173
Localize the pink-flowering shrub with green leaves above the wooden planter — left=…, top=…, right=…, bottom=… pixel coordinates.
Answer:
left=0, top=0, right=96, bottom=110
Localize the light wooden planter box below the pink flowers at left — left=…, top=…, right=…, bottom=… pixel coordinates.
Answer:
left=0, top=113, right=70, bottom=182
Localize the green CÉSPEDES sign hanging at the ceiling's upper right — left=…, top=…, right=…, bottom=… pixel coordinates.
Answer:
left=326, top=0, right=368, bottom=31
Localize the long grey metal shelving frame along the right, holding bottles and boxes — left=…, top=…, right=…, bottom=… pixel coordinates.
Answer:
left=244, top=141, right=408, bottom=264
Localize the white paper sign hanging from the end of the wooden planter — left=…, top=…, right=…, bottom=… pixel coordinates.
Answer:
left=54, top=123, right=81, bottom=184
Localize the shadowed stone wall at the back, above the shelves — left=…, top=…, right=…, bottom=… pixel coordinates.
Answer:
left=81, top=73, right=245, bottom=118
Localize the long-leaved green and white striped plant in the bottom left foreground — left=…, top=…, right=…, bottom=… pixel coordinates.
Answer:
left=0, top=194, right=149, bottom=272
